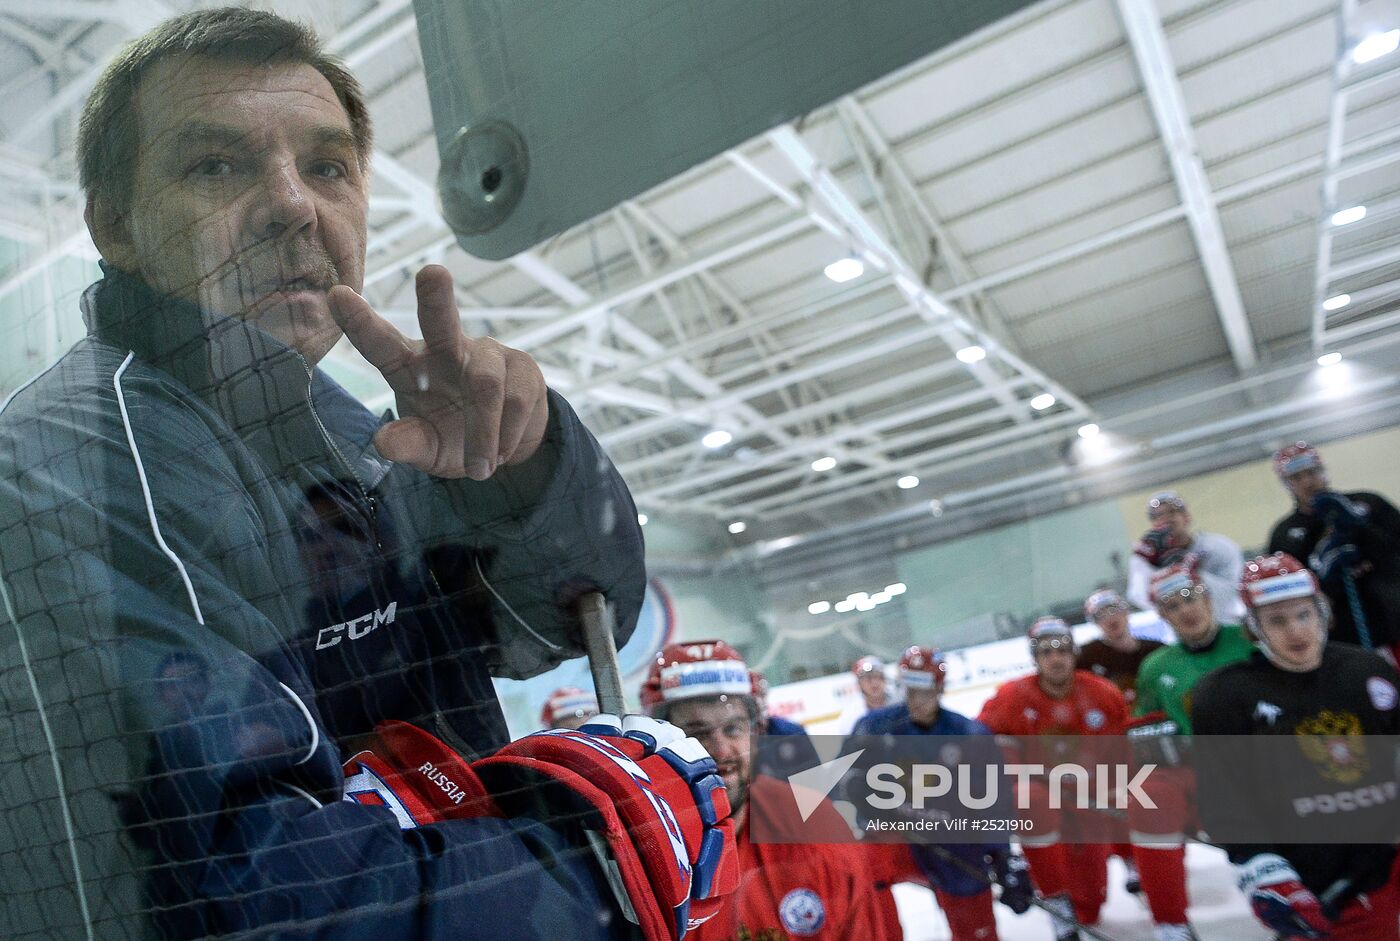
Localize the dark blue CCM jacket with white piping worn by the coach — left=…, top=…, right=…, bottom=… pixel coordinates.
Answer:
left=0, top=272, right=644, bottom=941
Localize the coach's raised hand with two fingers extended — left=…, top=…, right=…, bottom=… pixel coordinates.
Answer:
left=329, top=265, right=549, bottom=480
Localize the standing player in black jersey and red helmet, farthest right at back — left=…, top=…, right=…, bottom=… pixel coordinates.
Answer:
left=1268, top=441, right=1400, bottom=654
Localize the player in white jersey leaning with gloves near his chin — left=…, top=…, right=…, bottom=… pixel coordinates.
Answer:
left=1127, top=490, right=1245, bottom=625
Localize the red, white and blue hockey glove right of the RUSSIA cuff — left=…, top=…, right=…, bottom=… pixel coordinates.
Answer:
left=472, top=714, right=739, bottom=941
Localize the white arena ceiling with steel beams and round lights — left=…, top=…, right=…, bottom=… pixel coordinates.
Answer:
left=0, top=0, right=1400, bottom=568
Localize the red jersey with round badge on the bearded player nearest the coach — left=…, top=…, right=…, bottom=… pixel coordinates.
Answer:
left=686, top=774, right=885, bottom=941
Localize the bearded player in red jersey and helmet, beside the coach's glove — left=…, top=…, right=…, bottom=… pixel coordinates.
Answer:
left=641, top=640, right=885, bottom=941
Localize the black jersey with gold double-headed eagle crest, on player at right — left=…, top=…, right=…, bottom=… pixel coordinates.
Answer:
left=1191, top=643, right=1400, bottom=895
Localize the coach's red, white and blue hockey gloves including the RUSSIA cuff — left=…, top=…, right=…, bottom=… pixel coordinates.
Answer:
left=344, top=716, right=739, bottom=941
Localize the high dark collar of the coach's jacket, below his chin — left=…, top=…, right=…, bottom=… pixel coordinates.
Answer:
left=83, top=263, right=389, bottom=489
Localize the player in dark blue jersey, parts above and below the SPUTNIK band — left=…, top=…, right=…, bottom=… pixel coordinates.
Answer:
left=854, top=647, right=1033, bottom=941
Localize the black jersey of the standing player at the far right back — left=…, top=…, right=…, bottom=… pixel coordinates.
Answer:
left=1268, top=490, right=1400, bottom=644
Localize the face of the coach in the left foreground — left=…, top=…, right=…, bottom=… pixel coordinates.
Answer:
left=95, top=56, right=368, bottom=363
